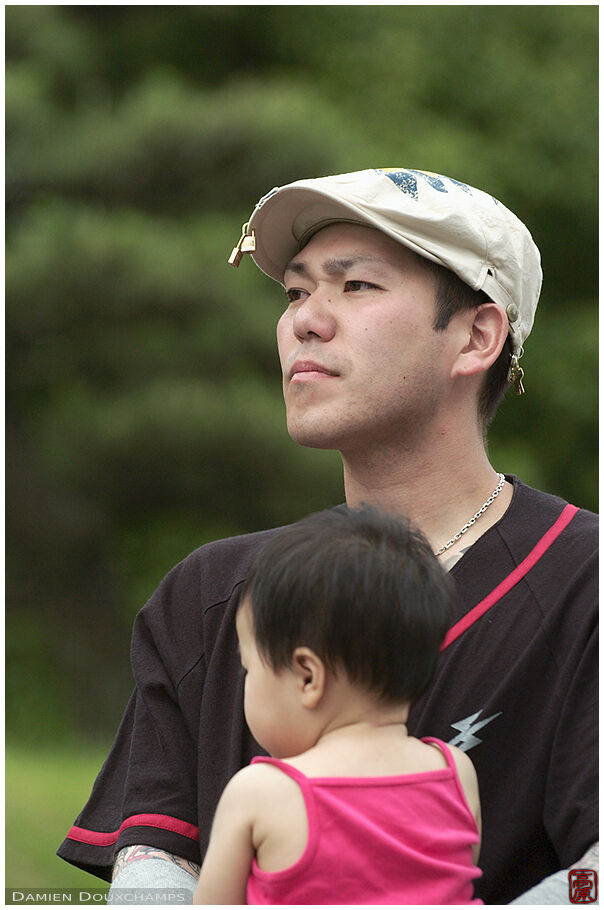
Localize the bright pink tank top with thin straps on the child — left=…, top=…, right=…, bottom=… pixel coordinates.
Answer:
left=247, top=738, right=482, bottom=904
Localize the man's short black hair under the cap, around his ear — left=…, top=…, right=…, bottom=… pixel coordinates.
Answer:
left=416, top=253, right=512, bottom=430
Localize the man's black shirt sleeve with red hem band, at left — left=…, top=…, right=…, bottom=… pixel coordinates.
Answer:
left=57, top=561, right=205, bottom=881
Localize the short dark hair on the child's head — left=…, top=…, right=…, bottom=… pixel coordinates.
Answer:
left=242, top=506, right=453, bottom=704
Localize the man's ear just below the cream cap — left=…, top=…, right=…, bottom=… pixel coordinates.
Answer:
left=451, top=301, right=509, bottom=378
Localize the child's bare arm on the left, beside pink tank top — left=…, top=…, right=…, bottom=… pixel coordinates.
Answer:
left=193, top=768, right=254, bottom=904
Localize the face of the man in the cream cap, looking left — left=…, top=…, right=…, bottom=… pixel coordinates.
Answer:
left=277, top=224, right=452, bottom=454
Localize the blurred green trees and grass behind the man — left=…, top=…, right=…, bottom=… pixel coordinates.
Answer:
left=5, top=6, right=598, bottom=887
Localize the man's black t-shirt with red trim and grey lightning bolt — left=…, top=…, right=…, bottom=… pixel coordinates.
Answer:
left=58, top=478, right=598, bottom=903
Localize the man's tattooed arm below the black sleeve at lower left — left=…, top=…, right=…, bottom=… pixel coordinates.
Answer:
left=107, top=844, right=200, bottom=904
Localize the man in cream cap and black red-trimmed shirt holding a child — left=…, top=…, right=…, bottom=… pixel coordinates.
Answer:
left=59, top=169, right=597, bottom=903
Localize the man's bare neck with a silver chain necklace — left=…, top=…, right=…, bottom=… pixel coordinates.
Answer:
left=342, top=426, right=512, bottom=559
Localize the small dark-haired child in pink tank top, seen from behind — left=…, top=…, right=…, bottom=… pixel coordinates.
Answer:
left=195, top=507, right=482, bottom=904
